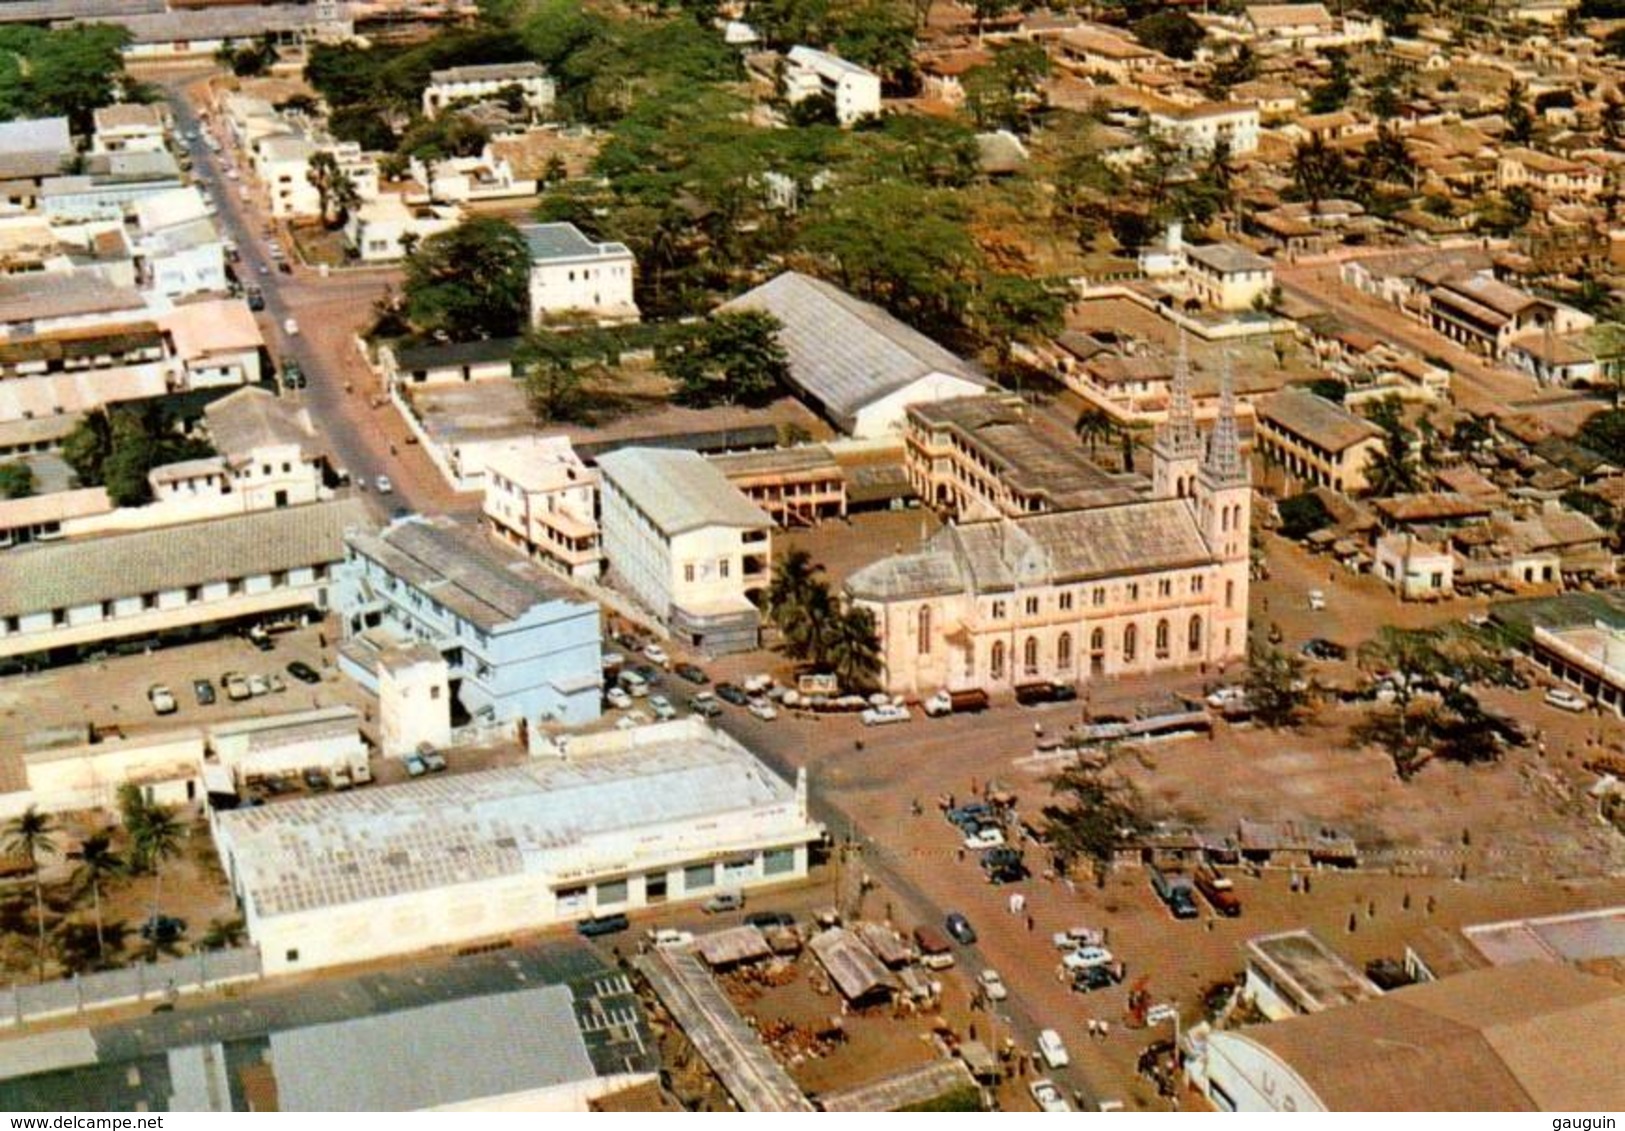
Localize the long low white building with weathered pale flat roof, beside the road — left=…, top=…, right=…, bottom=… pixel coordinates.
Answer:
left=215, top=718, right=822, bottom=973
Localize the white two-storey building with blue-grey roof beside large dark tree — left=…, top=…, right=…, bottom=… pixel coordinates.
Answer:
left=518, top=224, right=639, bottom=325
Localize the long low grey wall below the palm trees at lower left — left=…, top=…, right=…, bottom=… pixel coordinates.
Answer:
left=0, top=946, right=262, bottom=1025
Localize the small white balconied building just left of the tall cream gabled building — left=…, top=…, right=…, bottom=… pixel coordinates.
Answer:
left=484, top=436, right=603, bottom=580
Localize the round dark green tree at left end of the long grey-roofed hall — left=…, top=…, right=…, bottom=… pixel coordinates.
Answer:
left=661, top=310, right=790, bottom=408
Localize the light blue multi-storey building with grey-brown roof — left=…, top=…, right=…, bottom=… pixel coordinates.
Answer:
left=335, top=517, right=603, bottom=726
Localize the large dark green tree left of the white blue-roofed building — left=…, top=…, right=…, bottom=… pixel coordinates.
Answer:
left=405, top=218, right=530, bottom=341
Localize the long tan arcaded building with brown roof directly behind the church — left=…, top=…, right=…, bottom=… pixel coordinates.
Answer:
left=904, top=397, right=1149, bottom=522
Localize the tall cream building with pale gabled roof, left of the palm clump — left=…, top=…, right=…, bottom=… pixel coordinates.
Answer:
left=598, top=449, right=774, bottom=653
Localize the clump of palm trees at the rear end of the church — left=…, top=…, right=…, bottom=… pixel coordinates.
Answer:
left=767, top=549, right=882, bottom=692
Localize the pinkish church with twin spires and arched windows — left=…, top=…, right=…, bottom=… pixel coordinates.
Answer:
left=847, top=357, right=1251, bottom=696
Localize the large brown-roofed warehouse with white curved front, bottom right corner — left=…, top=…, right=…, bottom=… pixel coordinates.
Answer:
left=1198, top=962, right=1625, bottom=1112
